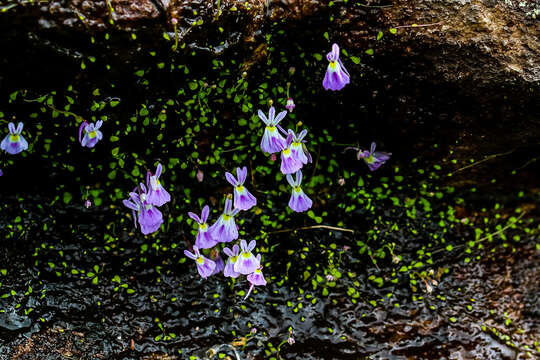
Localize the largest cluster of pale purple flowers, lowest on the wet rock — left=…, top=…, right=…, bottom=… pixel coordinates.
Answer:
left=184, top=167, right=266, bottom=298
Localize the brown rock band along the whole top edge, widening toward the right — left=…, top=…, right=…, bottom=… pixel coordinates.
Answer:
left=3, top=0, right=540, bottom=89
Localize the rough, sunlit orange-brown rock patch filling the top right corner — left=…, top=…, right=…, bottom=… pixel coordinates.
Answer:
left=382, top=0, right=540, bottom=86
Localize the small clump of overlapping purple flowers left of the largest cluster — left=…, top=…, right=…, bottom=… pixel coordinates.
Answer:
left=123, top=164, right=171, bottom=235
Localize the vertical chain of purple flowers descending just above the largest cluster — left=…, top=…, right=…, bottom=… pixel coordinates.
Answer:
left=258, top=106, right=313, bottom=212
